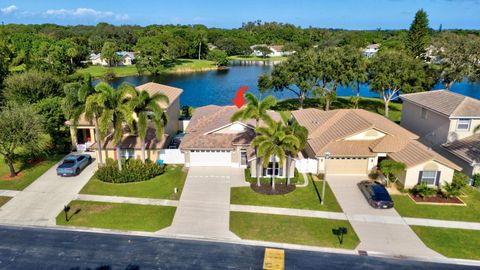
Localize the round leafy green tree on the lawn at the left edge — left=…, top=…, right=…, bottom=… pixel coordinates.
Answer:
left=0, top=104, right=46, bottom=177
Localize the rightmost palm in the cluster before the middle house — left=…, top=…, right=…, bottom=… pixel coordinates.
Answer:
left=281, top=114, right=308, bottom=185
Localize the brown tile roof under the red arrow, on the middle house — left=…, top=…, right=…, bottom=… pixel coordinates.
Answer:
left=180, top=105, right=280, bottom=149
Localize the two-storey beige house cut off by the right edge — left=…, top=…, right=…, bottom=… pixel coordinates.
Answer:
left=401, top=90, right=480, bottom=176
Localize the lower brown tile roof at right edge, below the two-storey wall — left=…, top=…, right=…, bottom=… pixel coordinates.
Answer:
left=442, top=133, right=480, bottom=163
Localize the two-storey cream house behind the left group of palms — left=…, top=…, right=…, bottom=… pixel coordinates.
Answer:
left=66, top=82, right=183, bottom=160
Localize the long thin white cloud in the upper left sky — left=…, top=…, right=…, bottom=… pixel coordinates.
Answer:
left=44, top=8, right=128, bottom=20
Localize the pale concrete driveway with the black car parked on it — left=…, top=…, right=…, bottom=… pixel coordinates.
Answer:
left=327, top=175, right=443, bottom=257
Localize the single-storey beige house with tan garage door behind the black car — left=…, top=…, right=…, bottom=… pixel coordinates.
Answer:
left=292, top=109, right=461, bottom=188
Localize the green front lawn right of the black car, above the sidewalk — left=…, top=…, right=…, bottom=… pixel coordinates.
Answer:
left=392, top=188, right=480, bottom=222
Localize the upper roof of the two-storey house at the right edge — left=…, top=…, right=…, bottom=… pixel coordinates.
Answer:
left=401, top=90, right=480, bottom=117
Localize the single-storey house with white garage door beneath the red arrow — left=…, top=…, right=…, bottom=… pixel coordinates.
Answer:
left=180, top=105, right=294, bottom=178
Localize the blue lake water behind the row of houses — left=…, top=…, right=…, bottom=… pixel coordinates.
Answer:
left=98, top=63, right=480, bottom=107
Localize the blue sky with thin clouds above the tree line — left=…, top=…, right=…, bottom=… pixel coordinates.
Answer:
left=0, top=0, right=480, bottom=29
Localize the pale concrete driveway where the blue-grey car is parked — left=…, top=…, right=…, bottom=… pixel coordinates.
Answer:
left=0, top=154, right=97, bottom=225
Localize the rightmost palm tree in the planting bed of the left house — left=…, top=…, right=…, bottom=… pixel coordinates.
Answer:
left=131, top=91, right=169, bottom=163
